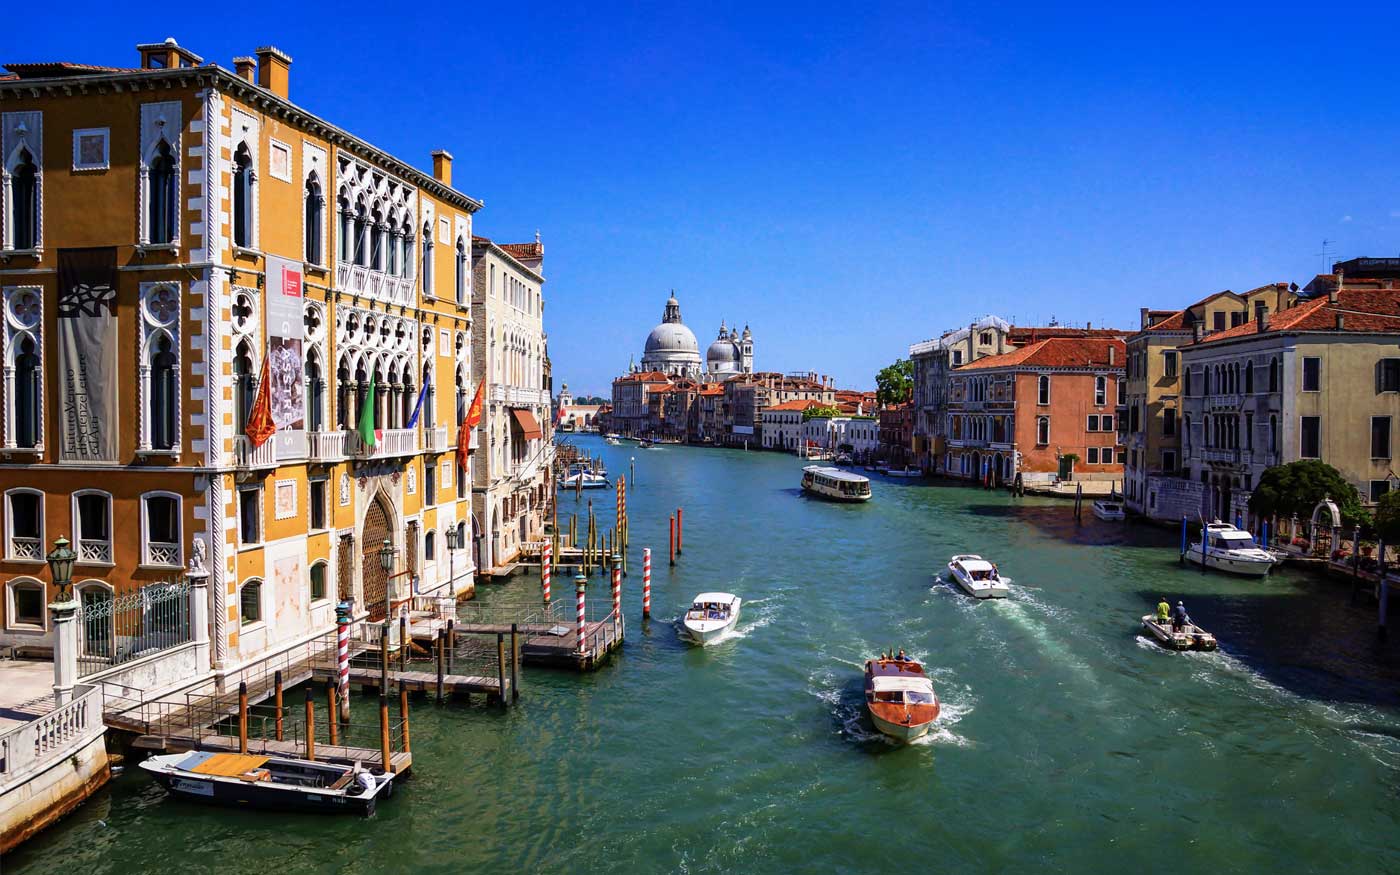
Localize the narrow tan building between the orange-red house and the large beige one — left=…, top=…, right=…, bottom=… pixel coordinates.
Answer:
left=1117, top=283, right=1295, bottom=521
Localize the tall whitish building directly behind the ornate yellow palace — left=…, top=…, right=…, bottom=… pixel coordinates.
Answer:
left=476, top=234, right=551, bottom=570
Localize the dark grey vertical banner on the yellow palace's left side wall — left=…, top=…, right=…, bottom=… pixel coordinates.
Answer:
left=55, top=246, right=118, bottom=462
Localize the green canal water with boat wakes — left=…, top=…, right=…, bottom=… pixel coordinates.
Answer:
left=4, top=438, right=1400, bottom=875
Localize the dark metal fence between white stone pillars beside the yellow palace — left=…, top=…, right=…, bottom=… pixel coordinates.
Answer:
left=78, top=581, right=190, bottom=678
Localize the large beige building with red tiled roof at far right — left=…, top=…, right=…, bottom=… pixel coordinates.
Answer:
left=1187, top=270, right=1400, bottom=519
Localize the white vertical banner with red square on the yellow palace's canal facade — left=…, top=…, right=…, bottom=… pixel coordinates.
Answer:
left=263, top=255, right=307, bottom=459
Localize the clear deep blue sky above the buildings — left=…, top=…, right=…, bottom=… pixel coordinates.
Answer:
left=19, top=3, right=1400, bottom=393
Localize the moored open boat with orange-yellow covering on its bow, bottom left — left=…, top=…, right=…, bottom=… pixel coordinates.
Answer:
left=140, top=750, right=393, bottom=815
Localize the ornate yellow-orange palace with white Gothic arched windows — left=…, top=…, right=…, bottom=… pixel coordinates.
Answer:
left=0, top=41, right=482, bottom=671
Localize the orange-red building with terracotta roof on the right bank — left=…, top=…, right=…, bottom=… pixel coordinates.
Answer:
left=944, top=329, right=1126, bottom=483
